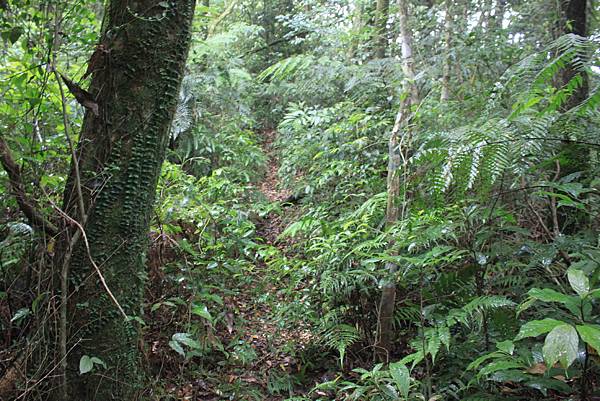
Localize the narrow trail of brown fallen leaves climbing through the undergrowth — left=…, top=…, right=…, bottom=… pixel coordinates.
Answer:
left=214, top=130, right=310, bottom=401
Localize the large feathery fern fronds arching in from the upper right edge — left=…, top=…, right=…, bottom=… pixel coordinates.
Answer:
left=418, top=34, right=600, bottom=195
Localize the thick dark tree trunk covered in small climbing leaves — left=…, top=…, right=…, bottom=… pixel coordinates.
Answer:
left=57, top=0, right=195, bottom=401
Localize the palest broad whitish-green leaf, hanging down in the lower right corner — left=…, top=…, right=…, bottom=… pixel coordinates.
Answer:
left=542, top=324, right=579, bottom=369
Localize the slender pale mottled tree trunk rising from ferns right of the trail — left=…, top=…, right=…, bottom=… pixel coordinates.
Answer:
left=375, top=0, right=419, bottom=362
